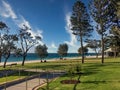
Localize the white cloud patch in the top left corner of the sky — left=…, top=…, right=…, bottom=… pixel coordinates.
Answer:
left=0, top=0, right=17, bottom=19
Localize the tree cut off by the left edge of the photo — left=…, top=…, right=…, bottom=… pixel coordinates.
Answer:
left=0, top=22, right=8, bottom=63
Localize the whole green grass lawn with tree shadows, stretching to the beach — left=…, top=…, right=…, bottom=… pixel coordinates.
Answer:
left=0, top=58, right=120, bottom=90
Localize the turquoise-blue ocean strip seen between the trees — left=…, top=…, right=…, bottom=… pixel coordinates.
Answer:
left=2, top=53, right=95, bottom=62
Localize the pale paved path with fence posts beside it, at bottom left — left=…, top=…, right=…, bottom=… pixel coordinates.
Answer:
left=1, top=72, right=65, bottom=90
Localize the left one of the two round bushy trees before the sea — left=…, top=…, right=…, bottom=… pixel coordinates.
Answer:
left=35, top=44, right=48, bottom=62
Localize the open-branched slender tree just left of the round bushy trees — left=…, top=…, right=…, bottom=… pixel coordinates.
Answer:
left=19, top=25, right=41, bottom=66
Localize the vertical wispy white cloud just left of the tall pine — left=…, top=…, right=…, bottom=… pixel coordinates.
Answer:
left=65, top=12, right=77, bottom=46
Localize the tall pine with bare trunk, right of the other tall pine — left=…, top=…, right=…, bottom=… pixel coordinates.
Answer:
left=90, top=0, right=116, bottom=63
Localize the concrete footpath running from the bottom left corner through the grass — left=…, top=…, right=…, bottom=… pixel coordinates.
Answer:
left=0, top=71, right=65, bottom=90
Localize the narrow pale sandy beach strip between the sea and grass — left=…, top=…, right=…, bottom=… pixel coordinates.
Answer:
left=0, top=56, right=101, bottom=66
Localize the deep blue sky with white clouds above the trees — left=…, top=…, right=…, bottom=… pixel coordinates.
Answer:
left=0, top=0, right=97, bottom=53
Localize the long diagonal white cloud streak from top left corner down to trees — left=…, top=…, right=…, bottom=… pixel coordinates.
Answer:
left=0, top=0, right=44, bottom=45
